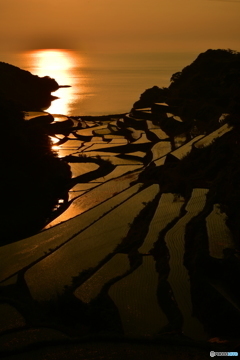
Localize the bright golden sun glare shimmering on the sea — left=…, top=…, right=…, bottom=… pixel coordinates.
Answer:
left=24, top=49, right=81, bottom=115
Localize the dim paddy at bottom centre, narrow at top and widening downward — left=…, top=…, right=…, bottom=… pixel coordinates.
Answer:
left=109, top=256, right=168, bottom=336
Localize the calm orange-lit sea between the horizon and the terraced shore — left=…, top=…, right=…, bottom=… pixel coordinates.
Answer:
left=0, top=49, right=198, bottom=116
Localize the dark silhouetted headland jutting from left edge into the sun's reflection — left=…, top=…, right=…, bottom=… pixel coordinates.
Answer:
left=0, top=62, right=59, bottom=111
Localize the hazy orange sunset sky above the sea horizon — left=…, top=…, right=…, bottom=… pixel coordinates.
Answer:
left=0, top=0, right=240, bottom=52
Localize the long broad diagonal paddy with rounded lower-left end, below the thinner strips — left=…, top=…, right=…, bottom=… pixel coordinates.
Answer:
left=25, top=185, right=158, bottom=300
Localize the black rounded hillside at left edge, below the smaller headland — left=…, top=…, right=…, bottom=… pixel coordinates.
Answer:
left=0, top=99, right=71, bottom=244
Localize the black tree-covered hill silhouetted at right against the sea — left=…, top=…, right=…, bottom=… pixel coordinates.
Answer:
left=133, top=49, right=240, bottom=131
